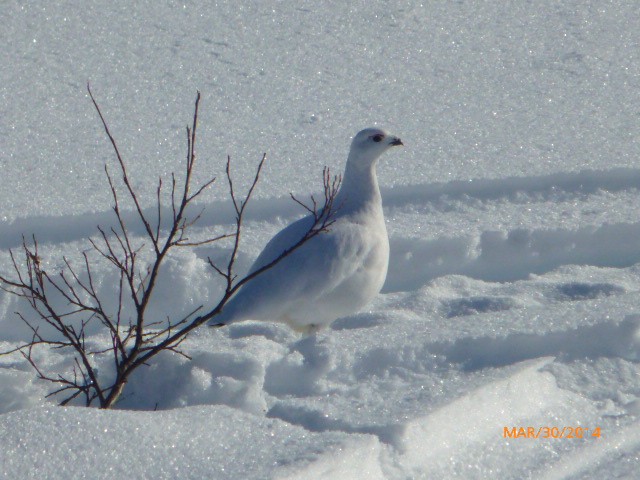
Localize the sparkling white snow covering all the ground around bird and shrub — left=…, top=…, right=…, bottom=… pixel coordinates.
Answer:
left=0, top=0, right=640, bottom=479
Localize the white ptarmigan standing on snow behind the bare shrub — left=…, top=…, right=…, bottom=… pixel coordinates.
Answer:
left=211, top=128, right=402, bottom=333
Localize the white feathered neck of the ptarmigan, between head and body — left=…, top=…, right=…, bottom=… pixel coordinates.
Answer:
left=335, top=161, right=382, bottom=214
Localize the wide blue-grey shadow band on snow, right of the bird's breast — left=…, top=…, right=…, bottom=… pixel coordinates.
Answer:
left=382, top=223, right=640, bottom=296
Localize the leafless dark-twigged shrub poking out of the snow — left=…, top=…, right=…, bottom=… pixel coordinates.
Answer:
left=0, top=85, right=340, bottom=408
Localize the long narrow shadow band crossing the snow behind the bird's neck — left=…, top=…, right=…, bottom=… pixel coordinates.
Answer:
left=0, top=168, right=640, bottom=248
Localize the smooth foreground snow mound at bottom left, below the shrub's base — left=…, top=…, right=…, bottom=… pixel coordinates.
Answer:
left=0, top=407, right=383, bottom=479
